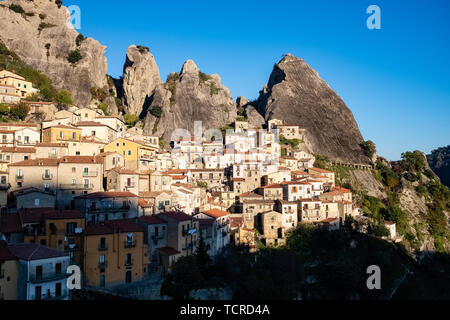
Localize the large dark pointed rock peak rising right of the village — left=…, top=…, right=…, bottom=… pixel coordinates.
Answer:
left=258, top=54, right=370, bottom=163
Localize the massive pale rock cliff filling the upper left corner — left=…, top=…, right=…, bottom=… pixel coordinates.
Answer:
left=0, top=0, right=112, bottom=109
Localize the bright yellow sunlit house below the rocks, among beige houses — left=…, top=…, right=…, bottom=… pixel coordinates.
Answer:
left=104, top=138, right=157, bottom=170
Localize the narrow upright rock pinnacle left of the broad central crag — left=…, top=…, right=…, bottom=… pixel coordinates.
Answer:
left=122, top=45, right=161, bottom=115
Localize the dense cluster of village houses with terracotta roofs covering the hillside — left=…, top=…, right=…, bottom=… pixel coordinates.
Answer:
left=0, top=70, right=395, bottom=300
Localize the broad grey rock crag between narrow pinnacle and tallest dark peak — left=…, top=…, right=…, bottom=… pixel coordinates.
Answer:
left=144, top=60, right=236, bottom=141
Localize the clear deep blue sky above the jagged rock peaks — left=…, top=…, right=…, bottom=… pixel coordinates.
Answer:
left=64, top=0, right=450, bottom=160
